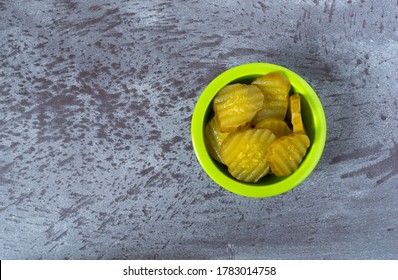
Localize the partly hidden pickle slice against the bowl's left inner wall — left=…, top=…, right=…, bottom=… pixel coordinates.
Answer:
left=205, top=117, right=229, bottom=163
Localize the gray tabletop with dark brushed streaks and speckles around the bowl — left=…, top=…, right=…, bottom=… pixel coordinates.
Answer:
left=0, top=0, right=398, bottom=259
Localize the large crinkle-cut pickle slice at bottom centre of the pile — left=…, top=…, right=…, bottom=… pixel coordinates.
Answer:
left=221, top=128, right=276, bottom=183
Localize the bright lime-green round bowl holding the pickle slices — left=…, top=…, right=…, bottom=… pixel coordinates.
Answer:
left=191, top=63, right=326, bottom=198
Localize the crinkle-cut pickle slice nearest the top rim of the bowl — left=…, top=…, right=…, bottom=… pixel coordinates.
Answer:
left=251, top=72, right=291, bottom=125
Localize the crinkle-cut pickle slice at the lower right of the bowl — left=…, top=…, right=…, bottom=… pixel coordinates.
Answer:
left=267, top=133, right=310, bottom=176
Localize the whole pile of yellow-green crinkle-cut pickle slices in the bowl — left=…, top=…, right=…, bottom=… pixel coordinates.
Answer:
left=205, top=72, right=310, bottom=183
